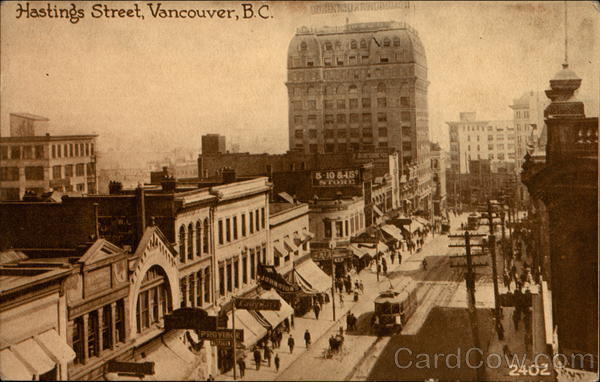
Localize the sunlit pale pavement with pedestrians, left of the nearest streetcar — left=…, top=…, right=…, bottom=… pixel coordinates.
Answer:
left=216, top=228, right=438, bottom=381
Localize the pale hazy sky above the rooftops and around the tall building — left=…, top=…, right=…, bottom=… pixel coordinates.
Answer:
left=0, top=1, right=600, bottom=159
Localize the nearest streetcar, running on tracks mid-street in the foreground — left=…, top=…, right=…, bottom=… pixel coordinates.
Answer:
left=372, top=280, right=417, bottom=333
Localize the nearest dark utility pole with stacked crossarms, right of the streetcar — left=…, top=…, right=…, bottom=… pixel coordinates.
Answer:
left=449, top=230, right=487, bottom=381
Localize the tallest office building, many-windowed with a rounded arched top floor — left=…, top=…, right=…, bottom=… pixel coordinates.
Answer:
left=286, top=22, right=431, bottom=209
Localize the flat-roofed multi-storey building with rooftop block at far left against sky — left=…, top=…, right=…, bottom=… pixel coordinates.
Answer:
left=0, top=113, right=98, bottom=200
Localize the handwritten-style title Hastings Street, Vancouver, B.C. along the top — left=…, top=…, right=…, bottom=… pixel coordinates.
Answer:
left=16, top=2, right=273, bottom=24
